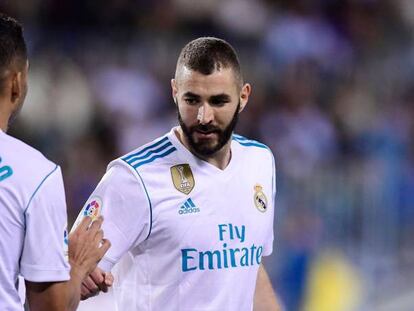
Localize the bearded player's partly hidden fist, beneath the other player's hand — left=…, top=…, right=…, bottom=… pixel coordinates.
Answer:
left=81, top=267, right=114, bottom=300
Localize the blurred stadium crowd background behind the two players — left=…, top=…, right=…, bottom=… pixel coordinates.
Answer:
left=0, top=0, right=414, bottom=311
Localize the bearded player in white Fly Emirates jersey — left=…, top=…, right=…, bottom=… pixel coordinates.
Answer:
left=78, top=38, right=278, bottom=311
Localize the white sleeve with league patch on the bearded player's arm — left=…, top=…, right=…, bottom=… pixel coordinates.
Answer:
left=72, top=164, right=151, bottom=271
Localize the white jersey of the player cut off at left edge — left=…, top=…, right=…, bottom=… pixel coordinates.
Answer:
left=0, top=131, right=70, bottom=311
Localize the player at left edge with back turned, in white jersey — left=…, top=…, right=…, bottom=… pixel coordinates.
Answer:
left=0, top=14, right=109, bottom=311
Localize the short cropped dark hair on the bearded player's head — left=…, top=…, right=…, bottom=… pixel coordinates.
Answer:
left=176, top=37, right=243, bottom=85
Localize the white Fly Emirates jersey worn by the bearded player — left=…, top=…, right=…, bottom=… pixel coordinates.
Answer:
left=77, top=128, right=275, bottom=311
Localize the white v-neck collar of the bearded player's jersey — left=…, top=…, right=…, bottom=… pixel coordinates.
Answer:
left=167, top=126, right=237, bottom=175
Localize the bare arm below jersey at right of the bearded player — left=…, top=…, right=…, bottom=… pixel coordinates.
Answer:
left=253, top=265, right=282, bottom=311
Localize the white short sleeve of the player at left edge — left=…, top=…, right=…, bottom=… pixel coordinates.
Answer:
left=20, top=166, right=70, bottom=282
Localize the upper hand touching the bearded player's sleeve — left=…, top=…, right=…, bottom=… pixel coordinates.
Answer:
left=69, top=216, right=111, bottom=281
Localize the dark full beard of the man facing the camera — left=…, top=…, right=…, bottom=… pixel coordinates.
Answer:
left=177, top=101, right=240, bottom=157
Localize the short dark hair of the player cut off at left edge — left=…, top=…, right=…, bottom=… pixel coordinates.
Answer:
left=0, top=13, right=27, bottom=72
